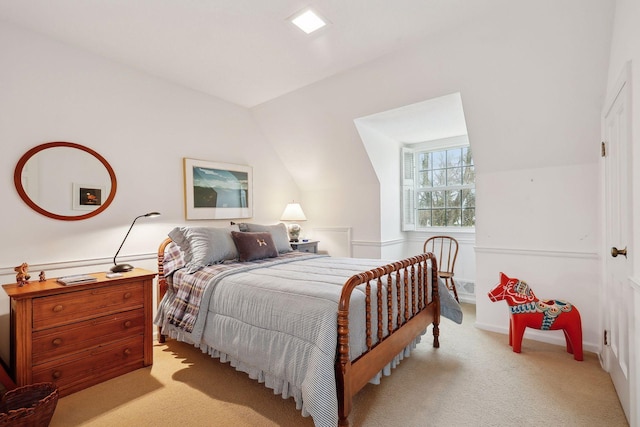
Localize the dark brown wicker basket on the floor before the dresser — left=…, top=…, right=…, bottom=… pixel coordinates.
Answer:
left=0, top=383, right=58, bottom=427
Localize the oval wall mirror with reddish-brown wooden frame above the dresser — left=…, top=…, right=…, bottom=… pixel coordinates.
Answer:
left=13, top=142, right=117, bottom=221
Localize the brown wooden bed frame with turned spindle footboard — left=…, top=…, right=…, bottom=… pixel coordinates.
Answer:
left=158, top=238, right=440, bottom=427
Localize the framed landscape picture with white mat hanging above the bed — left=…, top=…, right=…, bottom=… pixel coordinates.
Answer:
left=183, top=157, right=253, bottom=220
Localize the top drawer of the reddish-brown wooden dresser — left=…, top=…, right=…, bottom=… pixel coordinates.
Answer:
left=33, top=283, right=144, bottom=331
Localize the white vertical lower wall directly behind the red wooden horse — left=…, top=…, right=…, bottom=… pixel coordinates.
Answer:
left=476, top=164, right=601, bottom=352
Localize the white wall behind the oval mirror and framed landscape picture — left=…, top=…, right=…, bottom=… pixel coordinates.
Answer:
left=0, top=23, right=299, bottom=362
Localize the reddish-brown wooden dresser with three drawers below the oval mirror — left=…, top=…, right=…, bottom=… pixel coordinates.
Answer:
left=2, top=268, right=156, bottom=396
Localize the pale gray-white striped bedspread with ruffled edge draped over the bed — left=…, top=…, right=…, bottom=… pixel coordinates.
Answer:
left=155, top=254, right=462, bottom=427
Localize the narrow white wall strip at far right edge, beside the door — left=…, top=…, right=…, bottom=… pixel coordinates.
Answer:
left=607, top=0, right=640, bottom=426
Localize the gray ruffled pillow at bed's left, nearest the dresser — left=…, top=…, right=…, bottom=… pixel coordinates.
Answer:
left=169, top=226, right=238, bottom=273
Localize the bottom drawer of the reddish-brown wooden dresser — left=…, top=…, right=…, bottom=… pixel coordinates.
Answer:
left=33, top=335, right=144, bottom=395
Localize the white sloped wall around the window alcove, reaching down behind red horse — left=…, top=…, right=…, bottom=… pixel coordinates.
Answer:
left=252, top=0, right=614, bottom=350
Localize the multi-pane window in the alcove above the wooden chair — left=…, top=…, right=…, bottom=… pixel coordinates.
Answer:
left=402, top=145, right=476, bottom=230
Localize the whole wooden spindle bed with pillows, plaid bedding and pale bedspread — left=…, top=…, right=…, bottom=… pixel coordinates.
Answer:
left=155, top=224, right=461, bottom=427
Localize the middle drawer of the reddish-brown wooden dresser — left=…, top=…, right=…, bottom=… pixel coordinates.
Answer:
left=32, top=308, right=145, bottom=365
